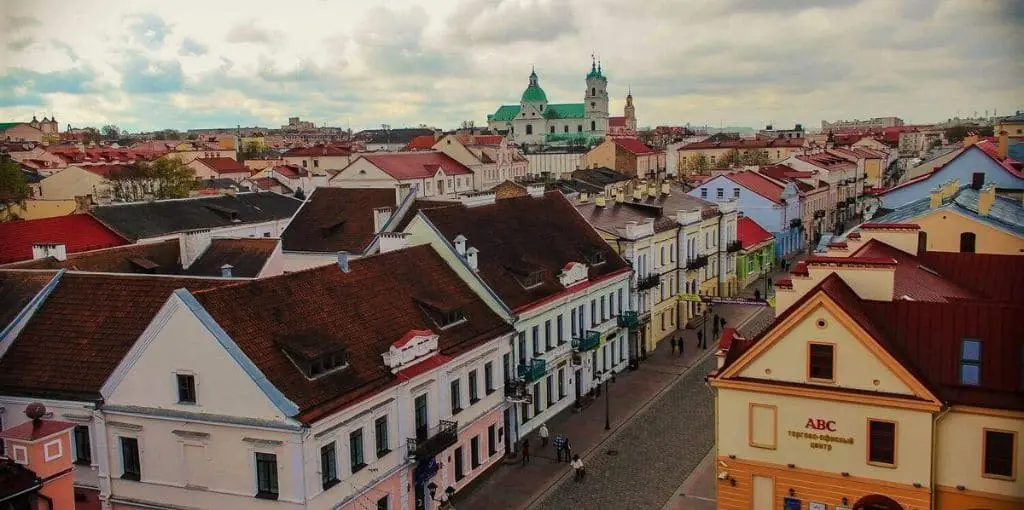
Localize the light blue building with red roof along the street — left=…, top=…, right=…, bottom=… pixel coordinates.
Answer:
left=689, top=172, right=804, bottom=260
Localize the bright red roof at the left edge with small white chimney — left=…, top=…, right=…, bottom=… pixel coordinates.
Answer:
left=0, top=214, right=128, bottom=264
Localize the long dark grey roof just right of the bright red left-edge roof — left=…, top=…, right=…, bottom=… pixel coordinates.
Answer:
left=89, top=192, right=302, bottom=242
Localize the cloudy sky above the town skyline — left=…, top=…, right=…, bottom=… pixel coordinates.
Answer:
left=0, top=0, right=1024, bottom=130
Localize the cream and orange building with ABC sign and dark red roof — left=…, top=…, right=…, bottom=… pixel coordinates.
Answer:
left=709, top=224, right=1024, bottom=510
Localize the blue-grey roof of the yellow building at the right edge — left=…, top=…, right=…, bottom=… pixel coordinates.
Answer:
left=871, top=186, right=1024, bottom=237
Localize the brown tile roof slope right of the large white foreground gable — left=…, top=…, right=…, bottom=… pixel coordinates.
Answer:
left=196, top=245, right=512, bottom=422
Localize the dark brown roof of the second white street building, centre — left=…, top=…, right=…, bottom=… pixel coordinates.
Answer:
left=422, top=192, right=629, bottom=310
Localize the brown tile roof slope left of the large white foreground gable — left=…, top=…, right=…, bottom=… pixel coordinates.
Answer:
left=0, top=272, right=232, bottom=400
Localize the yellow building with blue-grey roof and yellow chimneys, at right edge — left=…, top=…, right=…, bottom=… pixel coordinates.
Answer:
left=872, top=179, right=1024, bottom=255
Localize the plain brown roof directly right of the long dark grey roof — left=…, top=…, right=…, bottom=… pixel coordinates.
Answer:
left=281, top=187, right=397, bottom=253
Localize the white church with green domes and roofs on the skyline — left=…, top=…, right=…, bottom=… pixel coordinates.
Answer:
left=487, top=60, right=608, bottom=143
